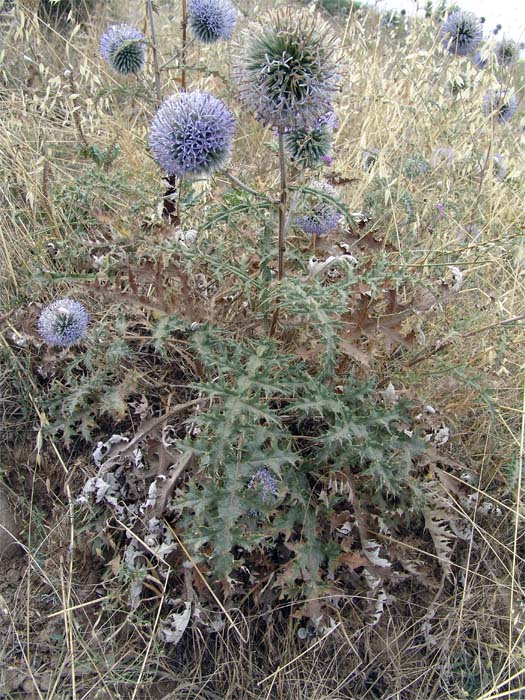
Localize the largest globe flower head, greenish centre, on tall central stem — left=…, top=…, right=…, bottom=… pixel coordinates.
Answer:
left=235, top=8, right=340, bottom=130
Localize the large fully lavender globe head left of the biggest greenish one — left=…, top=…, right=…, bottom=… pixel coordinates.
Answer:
left=149, top=92, right=235, bottom=177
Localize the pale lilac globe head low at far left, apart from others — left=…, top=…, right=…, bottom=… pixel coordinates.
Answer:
left=37, top=298, right=89, bottom=347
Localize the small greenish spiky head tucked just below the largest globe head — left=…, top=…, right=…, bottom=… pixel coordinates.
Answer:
left=284, top=112, right=339, bottom=168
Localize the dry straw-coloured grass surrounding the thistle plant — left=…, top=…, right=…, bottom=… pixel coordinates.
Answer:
left=0, top=2, right=525, bottom=700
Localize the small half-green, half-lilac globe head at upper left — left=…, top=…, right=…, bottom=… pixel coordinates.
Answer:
left=100, top=24, right=146, bottom=75
